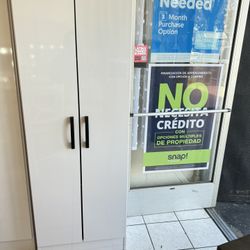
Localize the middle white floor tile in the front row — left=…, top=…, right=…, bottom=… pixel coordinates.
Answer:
left=147, top=222, right=192, bottom=250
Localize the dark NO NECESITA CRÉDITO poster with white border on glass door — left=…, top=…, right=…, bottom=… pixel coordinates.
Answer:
left=143, top=64, right=222, bottom=172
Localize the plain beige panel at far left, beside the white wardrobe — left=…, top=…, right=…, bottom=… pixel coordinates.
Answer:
left=0, top=0, right=32, bottom=243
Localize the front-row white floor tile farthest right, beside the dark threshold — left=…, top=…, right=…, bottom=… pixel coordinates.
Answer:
left=181, top=219, right=227, bottom=248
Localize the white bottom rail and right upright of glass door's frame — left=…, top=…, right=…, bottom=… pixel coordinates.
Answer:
left=127, top=0, right=250, bottom=216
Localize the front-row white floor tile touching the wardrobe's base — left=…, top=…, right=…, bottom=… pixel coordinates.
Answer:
left=126, top=225, right=153, bottom=250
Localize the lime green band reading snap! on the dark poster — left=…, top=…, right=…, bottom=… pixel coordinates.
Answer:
left=143, top=149, right=211, bottom=167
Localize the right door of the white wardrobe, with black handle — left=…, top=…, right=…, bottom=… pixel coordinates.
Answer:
left=76, top=0, right=134, bottom=241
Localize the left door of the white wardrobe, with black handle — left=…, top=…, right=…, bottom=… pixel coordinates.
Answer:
left=12, top=0, right=82, bottom=247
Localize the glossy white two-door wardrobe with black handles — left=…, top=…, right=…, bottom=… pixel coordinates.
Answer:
left=11, top=0, right=133, bottom=250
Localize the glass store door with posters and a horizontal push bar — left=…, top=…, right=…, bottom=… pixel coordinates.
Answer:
left=128, top=0, right=248, bottom=215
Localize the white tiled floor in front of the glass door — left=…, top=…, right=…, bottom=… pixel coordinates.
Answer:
left=126, top=209, right=227, bottom=250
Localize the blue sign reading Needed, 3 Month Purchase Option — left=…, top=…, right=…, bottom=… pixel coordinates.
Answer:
left=151, top=0, right=227, bottom=62
